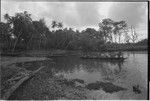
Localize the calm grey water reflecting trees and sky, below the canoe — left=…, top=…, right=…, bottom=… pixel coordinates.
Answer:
left=17, top=52, right=147, bottom=99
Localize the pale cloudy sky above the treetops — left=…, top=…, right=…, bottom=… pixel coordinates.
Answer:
left=1, top=0, right=148, bottom=40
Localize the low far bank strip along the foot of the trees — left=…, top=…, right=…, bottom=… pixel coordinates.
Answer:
left=0, top=43, right=148, bottom=57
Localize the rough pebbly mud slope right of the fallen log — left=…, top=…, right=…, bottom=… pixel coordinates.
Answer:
left=9, top=68, right=88, bottom=100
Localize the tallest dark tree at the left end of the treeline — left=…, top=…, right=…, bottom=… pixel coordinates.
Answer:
left=4, top=11, right=33, bottom=52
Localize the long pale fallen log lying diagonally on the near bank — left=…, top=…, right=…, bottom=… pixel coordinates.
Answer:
left=2, top=67, right=44, bottom=100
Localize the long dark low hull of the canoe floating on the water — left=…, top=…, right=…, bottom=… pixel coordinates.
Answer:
left=80, top=56, right=126, bottom=61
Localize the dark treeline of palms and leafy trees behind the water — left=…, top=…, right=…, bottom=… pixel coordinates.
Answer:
left=0, top=11, right=145, bottom=52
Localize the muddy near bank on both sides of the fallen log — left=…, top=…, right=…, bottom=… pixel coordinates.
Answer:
left=1, top=57, right=87, bottom=100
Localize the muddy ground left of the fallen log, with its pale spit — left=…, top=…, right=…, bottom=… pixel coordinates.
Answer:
left=0, top=57, right=51, bottom=97
